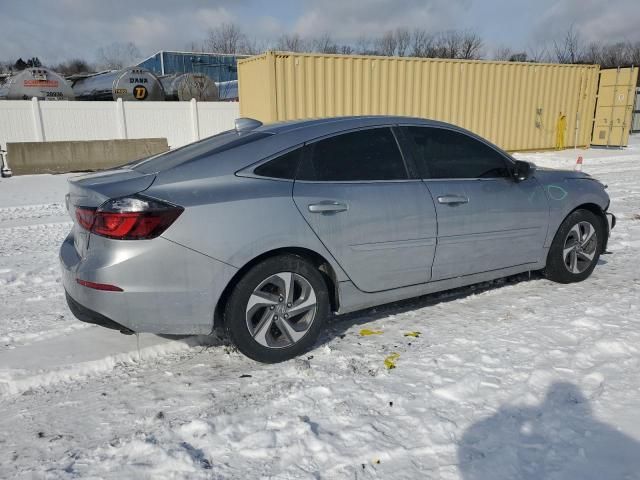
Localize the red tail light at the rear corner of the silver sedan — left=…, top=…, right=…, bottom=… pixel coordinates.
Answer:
left=76, top=196, right=184, bottom=240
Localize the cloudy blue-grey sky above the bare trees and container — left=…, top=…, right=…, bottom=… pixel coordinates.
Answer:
left=0, top=0, right=640, bottom=64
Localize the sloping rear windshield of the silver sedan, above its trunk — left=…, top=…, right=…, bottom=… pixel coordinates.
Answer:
left=129, top=130, right=272, bottom=173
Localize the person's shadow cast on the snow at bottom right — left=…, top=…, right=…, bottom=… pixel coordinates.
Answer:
left=458, top=382, right=640, bottom=480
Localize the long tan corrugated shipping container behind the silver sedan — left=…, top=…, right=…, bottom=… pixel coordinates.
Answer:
left=238, top=52, right=599, bottom=151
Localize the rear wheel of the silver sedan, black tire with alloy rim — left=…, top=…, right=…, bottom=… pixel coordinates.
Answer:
left=224, top=255, right=330, bottom=363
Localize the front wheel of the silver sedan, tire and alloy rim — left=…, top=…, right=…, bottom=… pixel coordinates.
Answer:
left=544, top=209, right=606, bottom=283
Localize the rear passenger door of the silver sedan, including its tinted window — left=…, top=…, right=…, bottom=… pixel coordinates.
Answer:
left=293, top=127, right=437, bottom=292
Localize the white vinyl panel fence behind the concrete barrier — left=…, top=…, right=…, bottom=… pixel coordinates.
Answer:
left=0, top=98, right=239, bottom=148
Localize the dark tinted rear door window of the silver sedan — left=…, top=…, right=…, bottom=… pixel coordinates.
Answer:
left=296, top=127, right=407, bottom=182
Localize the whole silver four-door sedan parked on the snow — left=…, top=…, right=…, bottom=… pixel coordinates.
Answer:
left=60, top=116, right=615, bottom=362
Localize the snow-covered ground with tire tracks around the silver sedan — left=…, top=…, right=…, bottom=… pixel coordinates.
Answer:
left=0, top=137, right=640, bottom=480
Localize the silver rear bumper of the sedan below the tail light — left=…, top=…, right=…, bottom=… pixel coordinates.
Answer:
left=60, top=229, right=237, bottom=335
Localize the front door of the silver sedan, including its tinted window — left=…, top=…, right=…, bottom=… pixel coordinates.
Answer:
left=401, top=126, right=549, bottom=280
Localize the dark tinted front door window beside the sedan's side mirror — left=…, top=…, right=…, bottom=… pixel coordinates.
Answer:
left=403, top=127, right=510, bottom=178
